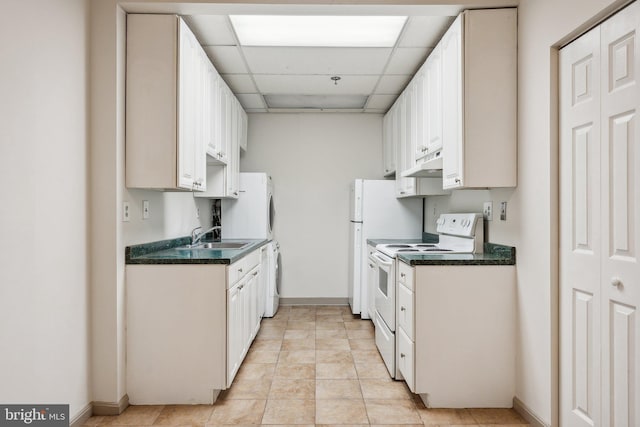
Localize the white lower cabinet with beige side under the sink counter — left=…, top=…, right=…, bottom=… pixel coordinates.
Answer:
left=125, top=249, right=261, bottom=405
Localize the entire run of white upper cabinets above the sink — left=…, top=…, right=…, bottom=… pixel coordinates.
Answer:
left=126, top=14, right=248, bottom=197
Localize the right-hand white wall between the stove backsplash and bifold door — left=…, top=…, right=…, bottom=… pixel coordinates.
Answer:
left=425, top=0, right=624, bottom=425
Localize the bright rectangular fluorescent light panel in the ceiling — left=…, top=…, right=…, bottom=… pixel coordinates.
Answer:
left=229, top=15, right=407, bottom=47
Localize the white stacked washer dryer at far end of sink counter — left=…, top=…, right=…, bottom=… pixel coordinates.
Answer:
left=221, top=172, right=280, bottom=317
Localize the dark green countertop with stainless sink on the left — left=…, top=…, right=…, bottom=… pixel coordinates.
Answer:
left=125, top=237, right=268, bottom=264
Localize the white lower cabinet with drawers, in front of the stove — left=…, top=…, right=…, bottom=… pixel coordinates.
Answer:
left=396, top=262, right=516, bottom=408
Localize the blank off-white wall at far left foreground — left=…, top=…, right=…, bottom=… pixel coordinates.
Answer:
left=0, top=0, right=91, bottom=418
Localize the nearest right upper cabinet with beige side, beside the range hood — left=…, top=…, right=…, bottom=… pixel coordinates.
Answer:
left=441, top=9, right=517, bottom=188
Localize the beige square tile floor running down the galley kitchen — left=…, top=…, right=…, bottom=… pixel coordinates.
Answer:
left=85, top=306, right=527, bottom=427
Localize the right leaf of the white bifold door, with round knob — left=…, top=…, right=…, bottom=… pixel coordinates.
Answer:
left=600, top=2, right=640, bottom=427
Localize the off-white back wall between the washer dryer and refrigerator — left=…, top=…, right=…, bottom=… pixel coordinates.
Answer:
left=239, top=113, right=382, bottom=298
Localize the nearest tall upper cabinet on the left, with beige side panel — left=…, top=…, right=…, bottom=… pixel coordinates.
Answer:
left=126, top=14, right=208, bottom=191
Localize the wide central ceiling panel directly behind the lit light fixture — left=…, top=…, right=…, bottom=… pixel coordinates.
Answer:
left=242, top=47, right=392, bottom=74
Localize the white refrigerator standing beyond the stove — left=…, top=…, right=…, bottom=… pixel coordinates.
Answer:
left=349, top=179, right=422, bottom=319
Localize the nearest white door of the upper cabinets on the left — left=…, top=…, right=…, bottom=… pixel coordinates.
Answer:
left=178, top=20, right=199, bottom=190
